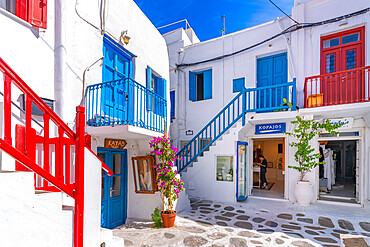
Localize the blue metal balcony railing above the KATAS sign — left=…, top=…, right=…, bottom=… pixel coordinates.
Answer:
left=85, top=78, right=167, bottom=133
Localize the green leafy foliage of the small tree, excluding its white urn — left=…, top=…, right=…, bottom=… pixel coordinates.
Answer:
left=284, top=116, right=343, bottom=181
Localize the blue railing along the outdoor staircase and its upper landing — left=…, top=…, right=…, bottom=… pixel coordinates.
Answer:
left=176, top=79, right=297, bottom=172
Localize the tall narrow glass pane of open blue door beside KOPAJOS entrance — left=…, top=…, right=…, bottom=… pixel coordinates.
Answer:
left=238, top=145, right=247, bottom=199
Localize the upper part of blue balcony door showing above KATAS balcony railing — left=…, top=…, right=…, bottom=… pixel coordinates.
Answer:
left=103, top=35, right=135, bottom=82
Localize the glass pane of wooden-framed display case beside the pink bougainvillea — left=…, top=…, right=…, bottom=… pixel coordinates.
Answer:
left=135, top=159, right=153, bottom=191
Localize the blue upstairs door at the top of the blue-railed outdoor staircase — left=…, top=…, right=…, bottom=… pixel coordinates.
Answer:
left=256, top=53, right=289, bottom=111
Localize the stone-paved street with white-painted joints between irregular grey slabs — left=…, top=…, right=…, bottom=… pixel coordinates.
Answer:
left=113, top=198, right=370, bottom=247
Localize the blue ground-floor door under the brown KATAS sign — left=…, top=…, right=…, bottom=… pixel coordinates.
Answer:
left=98, top=148, right=127, bottom=229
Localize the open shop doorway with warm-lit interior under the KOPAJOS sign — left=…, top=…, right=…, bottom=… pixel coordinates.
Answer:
left=253, top=138, right=285, bottom=199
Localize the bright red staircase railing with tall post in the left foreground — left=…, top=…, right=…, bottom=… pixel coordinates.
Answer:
left=0, top=58, right=112, bottom=247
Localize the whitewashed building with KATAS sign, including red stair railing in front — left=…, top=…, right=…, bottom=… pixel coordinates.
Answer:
left=0, top=0, right=189, bottom=246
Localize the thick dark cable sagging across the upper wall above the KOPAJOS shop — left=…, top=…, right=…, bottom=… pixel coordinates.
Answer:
left=176, top=7, right=370, bottom=68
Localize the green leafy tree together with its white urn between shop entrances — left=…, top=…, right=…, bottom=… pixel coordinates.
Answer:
left=285, top=116, right=341, bottom=206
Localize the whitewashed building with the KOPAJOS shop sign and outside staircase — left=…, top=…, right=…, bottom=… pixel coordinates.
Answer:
left=163, top=0, right=370, bottom=205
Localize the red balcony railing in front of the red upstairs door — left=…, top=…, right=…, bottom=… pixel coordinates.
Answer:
left=304, top=66, right=370, bottom=108
